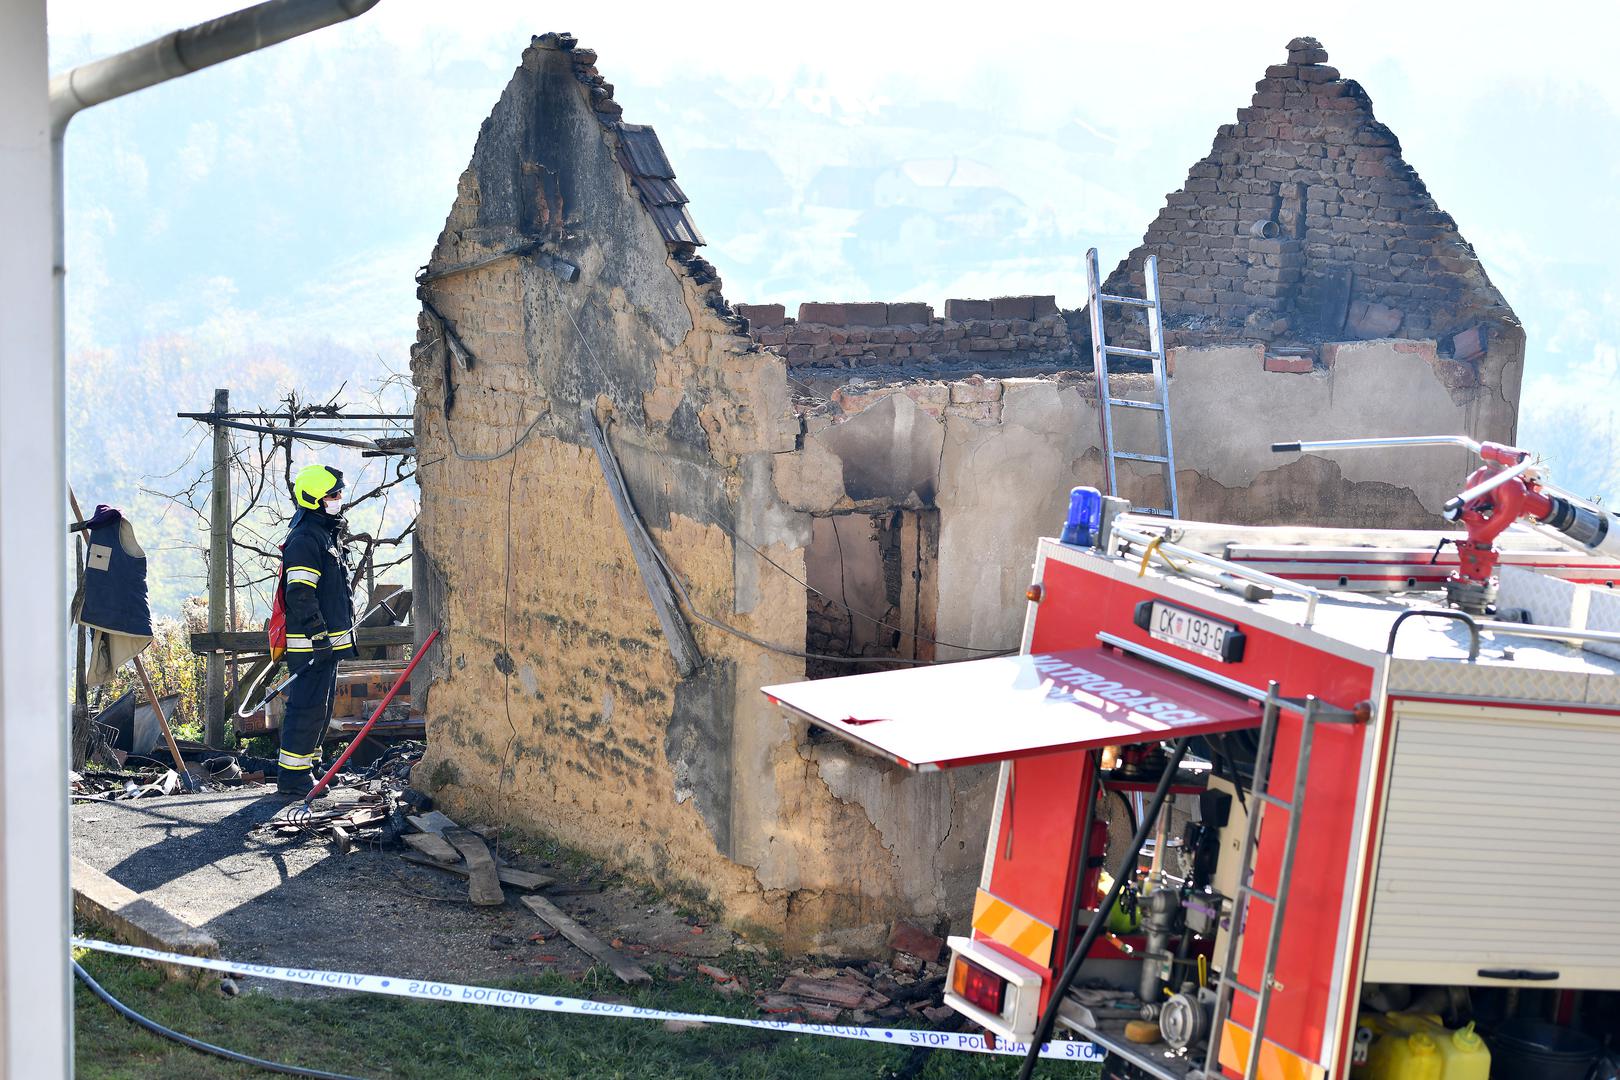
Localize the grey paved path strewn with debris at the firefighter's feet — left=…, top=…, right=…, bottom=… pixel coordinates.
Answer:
left=73, top=787, right=734, bottom=993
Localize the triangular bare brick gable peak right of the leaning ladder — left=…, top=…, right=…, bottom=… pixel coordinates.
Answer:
left=1105, top=37, right=1516, bottom=359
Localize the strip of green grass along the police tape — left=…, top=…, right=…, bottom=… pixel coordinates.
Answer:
left=73, top=952, right=1097, bottom=1080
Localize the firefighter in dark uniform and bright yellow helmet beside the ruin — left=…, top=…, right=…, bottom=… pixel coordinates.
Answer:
left=277, top=465, right=355, bottom=797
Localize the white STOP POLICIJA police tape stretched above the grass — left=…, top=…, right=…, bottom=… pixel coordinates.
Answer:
left=73, top=938, right=1105, bottom=1061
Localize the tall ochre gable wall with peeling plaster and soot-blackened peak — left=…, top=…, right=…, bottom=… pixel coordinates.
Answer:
left=411, top=39, right=993, bottom=949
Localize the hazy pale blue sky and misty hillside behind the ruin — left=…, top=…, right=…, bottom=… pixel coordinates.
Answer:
left=49, top=0, right=1620, bottom=592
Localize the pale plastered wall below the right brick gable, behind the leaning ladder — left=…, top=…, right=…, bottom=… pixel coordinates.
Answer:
left=776, top=340, right=1492, bottom=659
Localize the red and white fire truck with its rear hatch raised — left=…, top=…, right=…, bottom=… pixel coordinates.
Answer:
left=765, top=436, right=1620, bottom=1080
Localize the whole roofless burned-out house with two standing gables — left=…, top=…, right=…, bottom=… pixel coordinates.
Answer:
left=411, top=34, right=1524, bottom=949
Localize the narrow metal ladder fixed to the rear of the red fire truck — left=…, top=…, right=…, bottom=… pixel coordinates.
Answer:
left=1204, top=682, right=1354, bottom=1080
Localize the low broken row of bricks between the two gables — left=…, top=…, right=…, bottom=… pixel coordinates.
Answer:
left=734, top=296, right=1081, bottom=368
